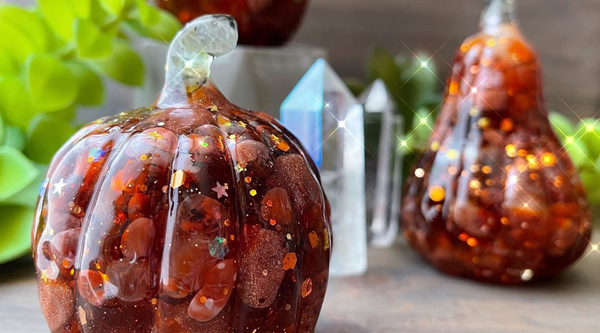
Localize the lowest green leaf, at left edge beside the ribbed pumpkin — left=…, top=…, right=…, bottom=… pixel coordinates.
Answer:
left=0, top=206, right=34, bottom=264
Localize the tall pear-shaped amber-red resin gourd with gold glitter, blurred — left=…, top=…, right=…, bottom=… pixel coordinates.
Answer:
left=402, top=0, right=591, bottom=284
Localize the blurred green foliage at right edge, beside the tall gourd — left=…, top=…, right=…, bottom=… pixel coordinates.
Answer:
left=550, top=112, right=600, bottom=205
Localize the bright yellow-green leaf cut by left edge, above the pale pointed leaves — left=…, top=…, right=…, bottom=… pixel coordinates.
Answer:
left=0, top=78, right=36, bottom=128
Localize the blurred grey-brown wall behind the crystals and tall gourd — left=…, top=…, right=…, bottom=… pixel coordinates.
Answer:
left=8, top=0, right=600, bottom=119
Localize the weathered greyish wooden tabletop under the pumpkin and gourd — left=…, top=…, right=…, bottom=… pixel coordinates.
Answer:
left=0, top=232, right=600, bottom=333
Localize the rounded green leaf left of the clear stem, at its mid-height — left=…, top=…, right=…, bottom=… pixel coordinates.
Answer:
left=95, top=40, right=144, bottom=86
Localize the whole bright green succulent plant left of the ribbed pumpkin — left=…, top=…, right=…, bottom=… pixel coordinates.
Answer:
left=0, top=0, right=180, bottom=264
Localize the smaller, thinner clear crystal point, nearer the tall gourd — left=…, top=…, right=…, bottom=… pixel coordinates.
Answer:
left=359, top=79, right=403, bottom=247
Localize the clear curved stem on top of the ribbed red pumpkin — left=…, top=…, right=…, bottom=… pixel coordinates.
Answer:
left=157, top=15, right=238, bottom=108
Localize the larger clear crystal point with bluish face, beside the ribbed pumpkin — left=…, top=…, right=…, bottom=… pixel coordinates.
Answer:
left=281, top=59, right=367, bottom=276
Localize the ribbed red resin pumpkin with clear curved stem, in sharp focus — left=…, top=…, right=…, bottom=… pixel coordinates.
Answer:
left=33, top=16, right=331, bottom=333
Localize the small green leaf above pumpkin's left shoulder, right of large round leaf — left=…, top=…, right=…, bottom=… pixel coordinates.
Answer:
left=67, top=62, right=104, bottom=106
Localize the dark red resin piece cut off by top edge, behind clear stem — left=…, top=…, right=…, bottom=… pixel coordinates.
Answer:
left=156, top=0, right=308, bottom=45
